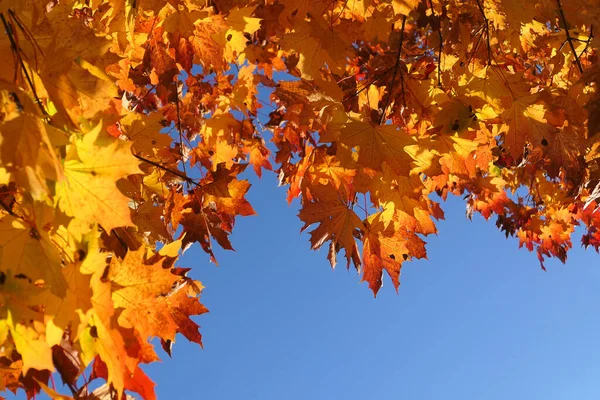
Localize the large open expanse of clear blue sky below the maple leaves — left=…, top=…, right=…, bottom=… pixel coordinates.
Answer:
left=142, top=174, right=600, bottom=400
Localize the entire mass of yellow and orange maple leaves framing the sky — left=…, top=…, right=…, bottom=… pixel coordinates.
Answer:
left=0, top=0, right=600, bottom=399
